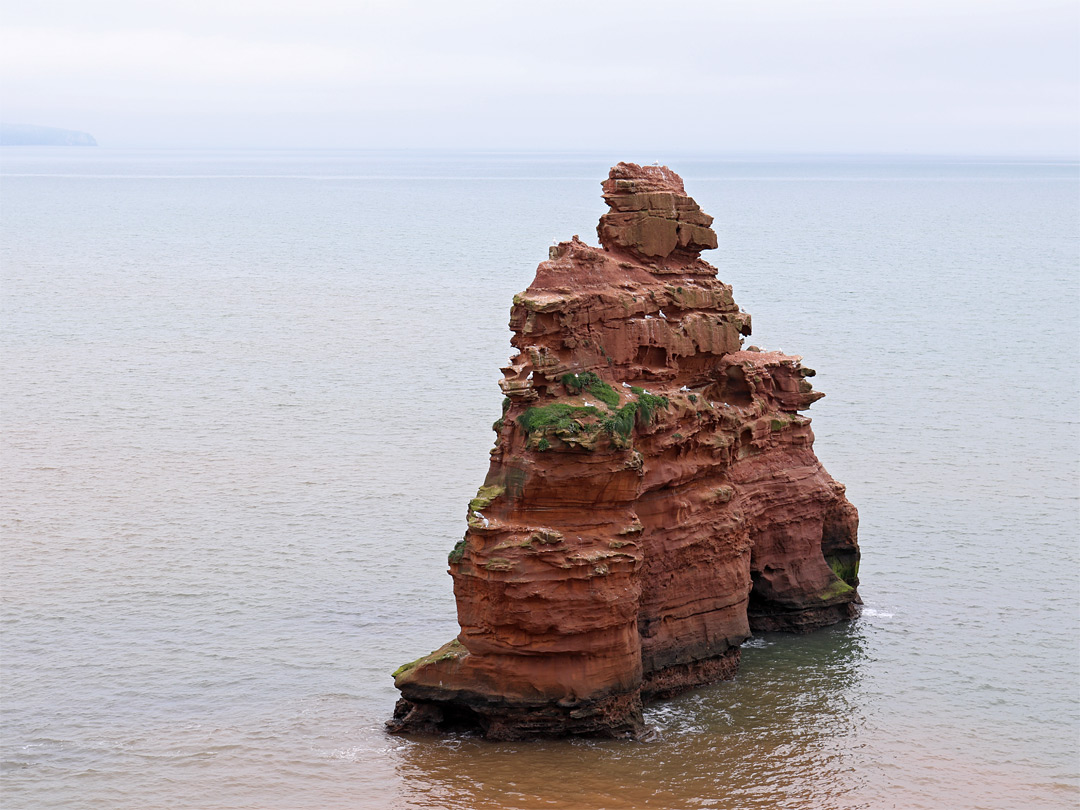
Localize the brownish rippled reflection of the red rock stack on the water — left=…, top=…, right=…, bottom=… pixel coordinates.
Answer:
left=397, top=622, right=865, bottom=810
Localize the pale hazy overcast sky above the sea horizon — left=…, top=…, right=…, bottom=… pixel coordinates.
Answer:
left=0, top=0, right=1080, bottom=156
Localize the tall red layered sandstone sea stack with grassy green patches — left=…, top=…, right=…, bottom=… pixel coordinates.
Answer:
left=388, top=163, right=859, bottom=740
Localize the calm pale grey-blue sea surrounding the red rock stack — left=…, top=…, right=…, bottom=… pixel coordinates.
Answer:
left=0, top=148, right=1080, bottom=810
